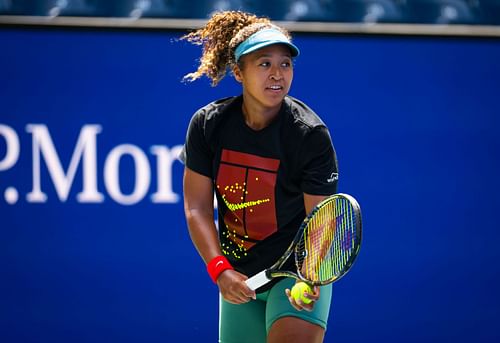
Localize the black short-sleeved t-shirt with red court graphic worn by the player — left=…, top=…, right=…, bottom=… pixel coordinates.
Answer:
left=181, top=96, right=338, bottom=291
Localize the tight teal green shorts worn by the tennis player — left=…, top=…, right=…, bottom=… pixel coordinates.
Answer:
left=219, top=278, right=332, bottom=343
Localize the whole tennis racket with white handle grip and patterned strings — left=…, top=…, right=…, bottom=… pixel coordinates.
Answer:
left=245, top=193, right=361, bottom=290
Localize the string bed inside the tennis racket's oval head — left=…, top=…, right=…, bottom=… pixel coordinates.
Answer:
left=296, top=198, right=356, bottom=283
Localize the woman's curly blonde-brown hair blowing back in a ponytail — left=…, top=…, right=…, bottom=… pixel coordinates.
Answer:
left=181, top=11, right=291, bottom=86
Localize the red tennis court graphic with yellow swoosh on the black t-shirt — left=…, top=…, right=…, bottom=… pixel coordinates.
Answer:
left=216, top=149, right=280, bottom=258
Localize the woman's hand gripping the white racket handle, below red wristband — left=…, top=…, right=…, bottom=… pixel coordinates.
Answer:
left=217, top=269, right=256, bottom=304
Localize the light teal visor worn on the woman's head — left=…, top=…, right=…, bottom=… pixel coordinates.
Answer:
left=234, top=29, right=300, bottom=62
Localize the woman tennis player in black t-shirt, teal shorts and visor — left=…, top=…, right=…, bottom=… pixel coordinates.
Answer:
left=181, top=11, right=338, bottom=343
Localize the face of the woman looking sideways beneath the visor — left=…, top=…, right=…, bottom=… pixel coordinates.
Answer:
left=234, top=44, right=293, bottom=108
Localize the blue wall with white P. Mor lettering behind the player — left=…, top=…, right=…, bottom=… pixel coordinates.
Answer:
left=0, top=27, right=500, bottom=343
